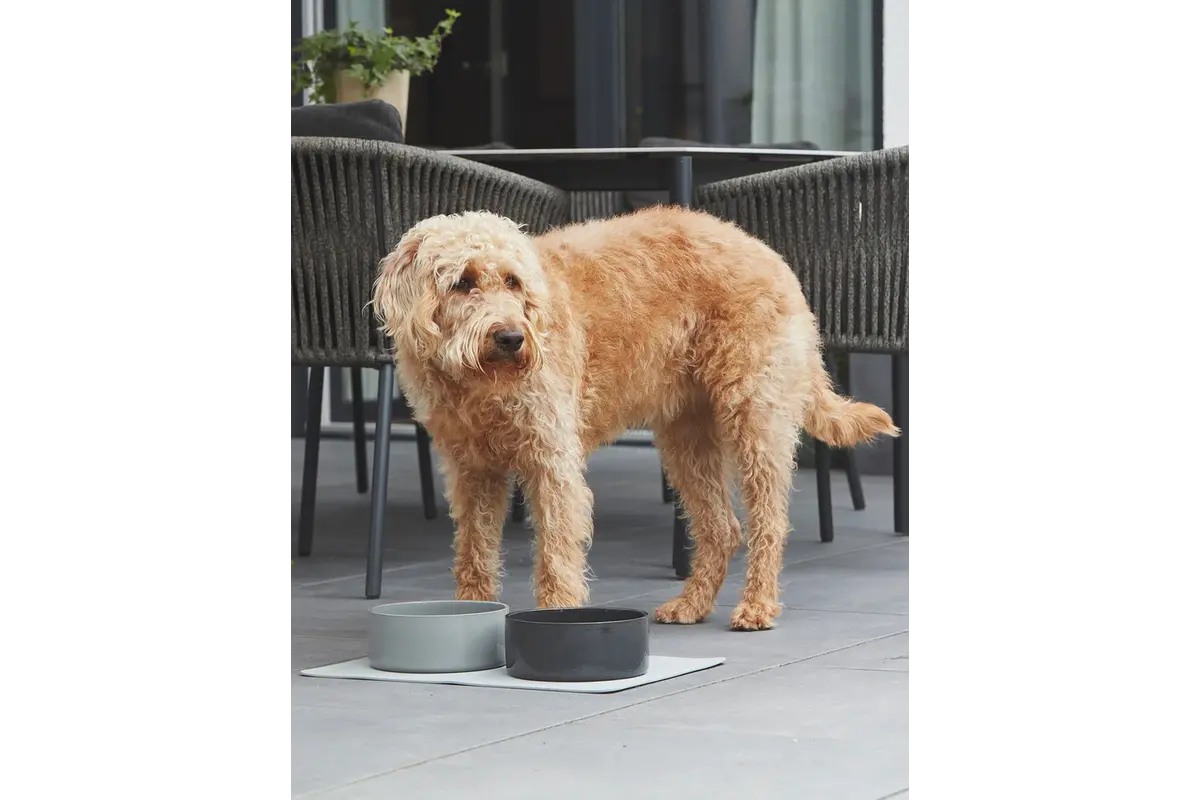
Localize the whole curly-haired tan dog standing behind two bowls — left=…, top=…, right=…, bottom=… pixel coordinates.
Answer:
left=374, top=206, right=899, bottom=631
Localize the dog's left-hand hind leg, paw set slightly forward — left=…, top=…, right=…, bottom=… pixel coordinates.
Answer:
left=654, top=403, right=742, bottom=625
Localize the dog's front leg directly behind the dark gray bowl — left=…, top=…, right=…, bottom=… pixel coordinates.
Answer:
left=523, top=457, right=592, bottom=608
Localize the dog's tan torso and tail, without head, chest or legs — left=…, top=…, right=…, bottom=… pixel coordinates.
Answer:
left=534, top=206, right=892, bottom=445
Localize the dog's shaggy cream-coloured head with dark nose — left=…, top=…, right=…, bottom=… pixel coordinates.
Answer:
left=373, top=211, right=548, bottom=380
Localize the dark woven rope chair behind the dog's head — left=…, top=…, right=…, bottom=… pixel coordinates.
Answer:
left=288, top=137, right=568, bottom=600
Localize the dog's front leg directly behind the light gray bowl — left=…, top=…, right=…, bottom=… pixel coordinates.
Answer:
left=446, top=464, right=509, bottom=600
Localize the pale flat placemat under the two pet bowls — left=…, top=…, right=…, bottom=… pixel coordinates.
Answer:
left=300, top=656, right=725, bottom=694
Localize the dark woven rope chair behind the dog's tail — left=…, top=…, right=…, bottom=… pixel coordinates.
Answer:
left=696, top=145, right=912, bottom=541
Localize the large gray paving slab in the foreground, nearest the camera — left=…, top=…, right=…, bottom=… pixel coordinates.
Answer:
left=297, top=664, right=912, bottom=800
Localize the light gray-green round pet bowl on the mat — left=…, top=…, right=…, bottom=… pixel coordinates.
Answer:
left=367, top=600, right=509, bottom=673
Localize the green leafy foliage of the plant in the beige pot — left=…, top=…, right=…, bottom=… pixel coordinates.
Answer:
left=288, top=8, right=460, bottom=103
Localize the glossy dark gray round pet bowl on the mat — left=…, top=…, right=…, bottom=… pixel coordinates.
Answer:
left=504, top=608, right=650, bottom=682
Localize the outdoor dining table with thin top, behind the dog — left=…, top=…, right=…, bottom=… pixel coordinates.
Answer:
left=442, top=146, right=858, bottom=578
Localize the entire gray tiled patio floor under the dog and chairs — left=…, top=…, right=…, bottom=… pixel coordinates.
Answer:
left=288, top=440, right=912, bottom=800
